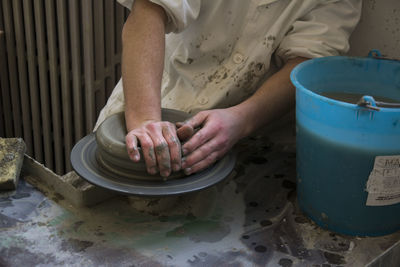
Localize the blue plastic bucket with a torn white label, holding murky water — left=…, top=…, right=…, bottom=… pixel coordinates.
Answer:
left=291, top=51, right=400, bottom=236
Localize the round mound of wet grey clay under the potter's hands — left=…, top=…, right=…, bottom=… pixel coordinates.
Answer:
left=95, top=109, right=193, bottom=180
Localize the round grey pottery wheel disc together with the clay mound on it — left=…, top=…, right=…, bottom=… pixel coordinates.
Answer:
left=71, top=109, right=235, bottom=196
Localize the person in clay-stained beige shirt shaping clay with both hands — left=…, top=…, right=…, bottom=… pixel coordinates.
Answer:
left=97, top=0, right=361, bottom=180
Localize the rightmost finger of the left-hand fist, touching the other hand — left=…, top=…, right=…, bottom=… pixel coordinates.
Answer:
left=162, top=123, right=182, bottom=174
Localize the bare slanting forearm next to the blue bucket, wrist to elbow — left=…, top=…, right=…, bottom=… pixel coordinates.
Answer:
left=231, top=57, right=307, bottom=137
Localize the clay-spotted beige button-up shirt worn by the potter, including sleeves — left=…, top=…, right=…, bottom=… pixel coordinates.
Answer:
left=96, top=0, right=361, bottom=130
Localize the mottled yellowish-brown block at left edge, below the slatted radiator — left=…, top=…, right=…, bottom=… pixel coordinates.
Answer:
left=0, top=137, right=26, bottom=190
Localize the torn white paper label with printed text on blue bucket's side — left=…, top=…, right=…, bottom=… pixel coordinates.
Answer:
left=366, top=155, right=400, bottom=206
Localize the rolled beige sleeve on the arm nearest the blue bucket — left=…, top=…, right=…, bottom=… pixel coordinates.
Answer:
left=276, top=0, right=361, bottom=62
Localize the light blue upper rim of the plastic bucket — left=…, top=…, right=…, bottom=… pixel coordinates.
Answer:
left=290, top=56, right=400, bottom=112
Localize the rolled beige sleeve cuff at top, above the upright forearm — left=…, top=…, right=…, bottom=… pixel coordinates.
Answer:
left=118, top=0, right=201, bottom=33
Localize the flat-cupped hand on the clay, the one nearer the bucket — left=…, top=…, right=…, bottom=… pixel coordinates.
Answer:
left=178, top=108, right=245, bottom=175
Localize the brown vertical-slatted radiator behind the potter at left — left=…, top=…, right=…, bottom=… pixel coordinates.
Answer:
left=0, top=0, right=128, bottom=175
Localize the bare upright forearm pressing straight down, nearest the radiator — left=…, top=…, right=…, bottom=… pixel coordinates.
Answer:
left=122, top=0, right=166, bottom=132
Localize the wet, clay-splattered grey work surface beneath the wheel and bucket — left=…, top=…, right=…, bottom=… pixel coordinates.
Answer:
left=0, top=120, right=400, bottom=267
